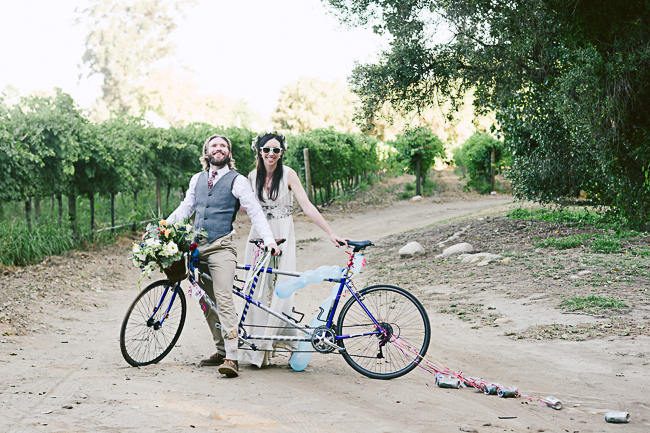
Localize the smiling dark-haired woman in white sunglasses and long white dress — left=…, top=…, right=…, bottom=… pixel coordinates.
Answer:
left=239, top=133, right=345, bottom=367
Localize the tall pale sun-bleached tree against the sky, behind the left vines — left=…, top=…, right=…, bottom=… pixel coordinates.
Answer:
left=77, top=0, right=179, bottom=118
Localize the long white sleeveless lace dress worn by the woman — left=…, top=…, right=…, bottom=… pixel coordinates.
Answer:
left=239, top=170, right=298, bottom=367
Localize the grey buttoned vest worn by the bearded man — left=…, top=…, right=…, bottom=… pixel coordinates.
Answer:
left=194, top=170, right=239, bottom=242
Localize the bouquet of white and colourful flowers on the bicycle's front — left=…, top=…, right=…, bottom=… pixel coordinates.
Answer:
left=131, top=220, right=204, bottom=282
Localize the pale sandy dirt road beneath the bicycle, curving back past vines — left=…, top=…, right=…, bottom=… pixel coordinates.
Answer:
left=0, top=197, right=650, bottom=433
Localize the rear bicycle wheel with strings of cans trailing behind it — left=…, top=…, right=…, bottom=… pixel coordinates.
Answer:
left=337, top=285, right=431, bottom=379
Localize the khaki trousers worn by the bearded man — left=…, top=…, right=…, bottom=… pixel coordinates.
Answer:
left=199, top=235, right=239, bottom=360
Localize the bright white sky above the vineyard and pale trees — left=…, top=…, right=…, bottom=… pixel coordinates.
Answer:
left=0, top=0, right=382, bottom=117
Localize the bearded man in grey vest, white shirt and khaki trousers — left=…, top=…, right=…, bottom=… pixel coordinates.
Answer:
left=167, top=135, right=279, bottom=377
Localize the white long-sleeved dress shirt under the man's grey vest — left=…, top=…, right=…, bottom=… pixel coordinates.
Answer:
left=167, top=166, right=275, bottom=245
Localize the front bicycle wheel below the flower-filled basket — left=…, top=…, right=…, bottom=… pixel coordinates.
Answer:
left=120, top=280, right=187, bottom=367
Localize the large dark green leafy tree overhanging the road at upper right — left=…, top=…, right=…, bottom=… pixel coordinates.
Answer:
left=327, top=0, right=650, bottom=226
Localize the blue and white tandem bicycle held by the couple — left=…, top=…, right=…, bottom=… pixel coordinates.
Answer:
left=120, top=240, right=431, bottom=379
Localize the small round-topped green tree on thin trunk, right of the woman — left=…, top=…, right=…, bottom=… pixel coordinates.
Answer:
left=395, top=127, right=445, bottom=195
